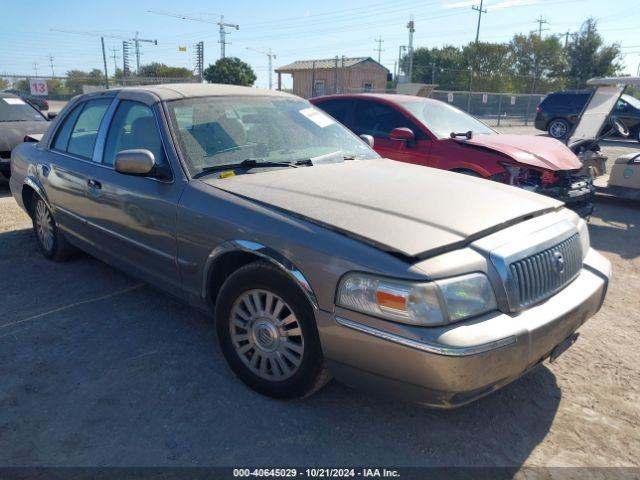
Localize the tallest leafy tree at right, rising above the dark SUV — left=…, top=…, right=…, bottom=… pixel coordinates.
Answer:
left=567, top=18, right=622, bottom=89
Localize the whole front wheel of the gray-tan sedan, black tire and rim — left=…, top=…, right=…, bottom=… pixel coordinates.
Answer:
left=215, top=262, right=331, bottom=399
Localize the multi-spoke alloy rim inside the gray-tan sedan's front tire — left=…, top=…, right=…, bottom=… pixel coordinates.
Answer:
left=229, top=290, right=304, bottom=381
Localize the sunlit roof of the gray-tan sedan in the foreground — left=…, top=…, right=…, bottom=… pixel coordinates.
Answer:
left=78, top=83, right=299, bottom=104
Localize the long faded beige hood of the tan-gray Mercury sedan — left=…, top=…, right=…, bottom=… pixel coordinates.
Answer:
left=204, top=159, right=562, bottom=257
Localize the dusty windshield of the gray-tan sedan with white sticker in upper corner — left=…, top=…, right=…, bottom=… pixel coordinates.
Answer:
left=167, top=96, right=378, bottom=174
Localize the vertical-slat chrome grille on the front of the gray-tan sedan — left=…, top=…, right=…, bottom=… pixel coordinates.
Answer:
left=509, top=234, right=582, bottom=308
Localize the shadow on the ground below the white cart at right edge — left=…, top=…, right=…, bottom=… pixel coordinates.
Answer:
left=589, top=200, right=640, bottom=259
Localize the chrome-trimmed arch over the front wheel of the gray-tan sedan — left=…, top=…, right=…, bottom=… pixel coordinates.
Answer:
left=202, top=240, right=319, bottom=310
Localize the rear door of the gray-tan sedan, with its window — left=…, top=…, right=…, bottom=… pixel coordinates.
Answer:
left=45, top=98, right=113, bottom=243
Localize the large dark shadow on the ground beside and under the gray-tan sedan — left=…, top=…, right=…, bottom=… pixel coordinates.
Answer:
left=0, top=230, right=561, bottom=468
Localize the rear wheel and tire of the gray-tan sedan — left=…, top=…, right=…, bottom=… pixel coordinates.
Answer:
left=31, top=192, right=75, bottom=262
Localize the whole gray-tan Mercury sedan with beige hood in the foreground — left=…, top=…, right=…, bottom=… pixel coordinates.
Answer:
left=10, top=84, right=610, bottom=408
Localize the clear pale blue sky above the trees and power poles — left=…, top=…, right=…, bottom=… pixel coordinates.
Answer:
left=0, top=0, right=640, bottom=88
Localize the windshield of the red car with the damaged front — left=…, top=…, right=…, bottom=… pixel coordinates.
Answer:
left=402, top=101, right=496, bottom=138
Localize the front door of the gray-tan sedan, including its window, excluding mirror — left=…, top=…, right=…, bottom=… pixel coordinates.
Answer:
left=84, top=100, right=184, bottom=293
